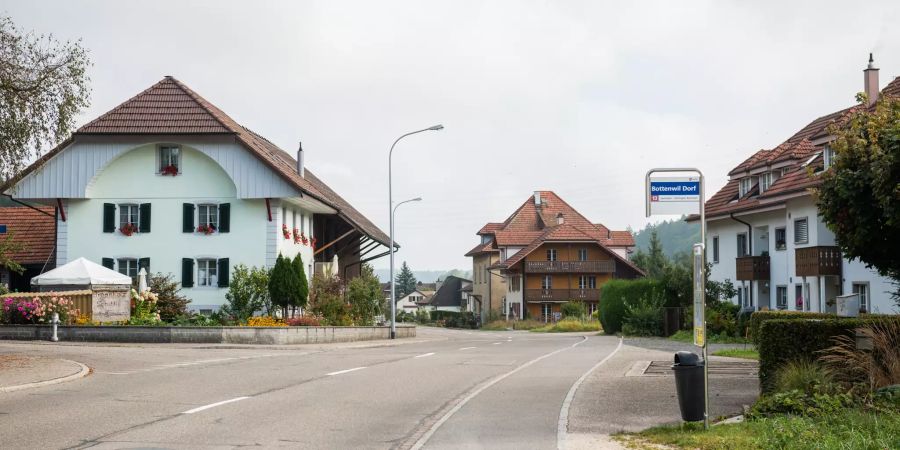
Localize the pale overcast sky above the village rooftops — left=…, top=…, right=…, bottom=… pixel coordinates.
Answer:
left=0, top=0, right=900, bottom=270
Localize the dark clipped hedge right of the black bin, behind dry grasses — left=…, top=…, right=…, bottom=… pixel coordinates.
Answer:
left=754, top=314, right=900, bottom=393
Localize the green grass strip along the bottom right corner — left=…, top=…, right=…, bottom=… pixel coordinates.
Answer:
left=616, top=409, right=900, bottom=450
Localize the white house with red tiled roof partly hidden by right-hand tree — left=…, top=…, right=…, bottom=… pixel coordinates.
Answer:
left=689, top=59, right=900, bottom=313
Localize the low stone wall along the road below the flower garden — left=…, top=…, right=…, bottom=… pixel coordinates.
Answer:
left=0, top=325, right=416, bottom=345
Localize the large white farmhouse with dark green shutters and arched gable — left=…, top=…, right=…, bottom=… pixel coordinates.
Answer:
left=0, top=77, right=389, bottom=310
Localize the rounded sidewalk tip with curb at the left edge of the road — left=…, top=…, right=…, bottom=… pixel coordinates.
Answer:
left=0, top=354, right=90, bottom=393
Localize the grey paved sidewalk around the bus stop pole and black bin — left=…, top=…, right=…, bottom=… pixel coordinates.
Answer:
left=568, top=339, right=759, bottom=448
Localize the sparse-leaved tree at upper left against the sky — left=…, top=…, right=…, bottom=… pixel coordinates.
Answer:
left=0, top=16, right=91, bottom=180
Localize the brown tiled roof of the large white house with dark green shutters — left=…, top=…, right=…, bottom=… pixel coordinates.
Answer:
left=0, top=77, right=390, bottom=246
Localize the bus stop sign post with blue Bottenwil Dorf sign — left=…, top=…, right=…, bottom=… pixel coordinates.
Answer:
left=645, top=168, right=709, bottom=429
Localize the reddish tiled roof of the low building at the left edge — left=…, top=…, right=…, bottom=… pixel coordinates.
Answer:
left=0, top=206, right=56, bottom=264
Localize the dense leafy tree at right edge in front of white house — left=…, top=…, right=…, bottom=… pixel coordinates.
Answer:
left=817, top=94, right=900, bottom=301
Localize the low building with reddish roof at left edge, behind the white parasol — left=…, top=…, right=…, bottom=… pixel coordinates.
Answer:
left=0, top=206, right=56, bottom=292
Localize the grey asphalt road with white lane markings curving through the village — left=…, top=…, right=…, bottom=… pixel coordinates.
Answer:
left=0, top=328, right=619, bottom=449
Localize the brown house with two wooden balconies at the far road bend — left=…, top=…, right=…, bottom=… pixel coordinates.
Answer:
left=466, top=191, right=643, bottom=321
